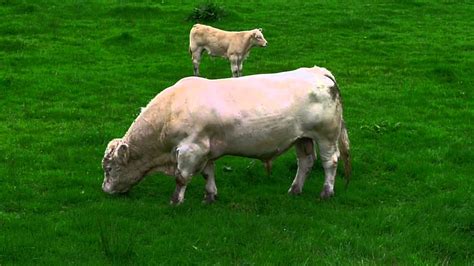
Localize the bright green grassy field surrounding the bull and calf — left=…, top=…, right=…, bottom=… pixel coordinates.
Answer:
left=0, top=0, right=474, bottom=265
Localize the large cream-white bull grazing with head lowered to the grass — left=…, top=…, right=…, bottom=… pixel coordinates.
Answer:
left=102, top=67, right=351, bottom=204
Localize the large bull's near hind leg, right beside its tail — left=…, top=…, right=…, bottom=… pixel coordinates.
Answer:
left=318, top=140, right=339, bottom=199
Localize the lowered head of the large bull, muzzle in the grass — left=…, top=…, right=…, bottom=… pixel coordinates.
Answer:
left=102, top=139, right=141, bottom=194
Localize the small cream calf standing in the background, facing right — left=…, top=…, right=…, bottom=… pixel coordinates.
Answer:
left=189, top=24, right=267, bottom=77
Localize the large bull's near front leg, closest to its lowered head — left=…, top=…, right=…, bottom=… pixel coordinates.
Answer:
left=170, top=143, right=209, bottom=205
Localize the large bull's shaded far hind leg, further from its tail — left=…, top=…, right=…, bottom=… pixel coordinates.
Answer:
left=288, top=138, right=316, bottom=195
